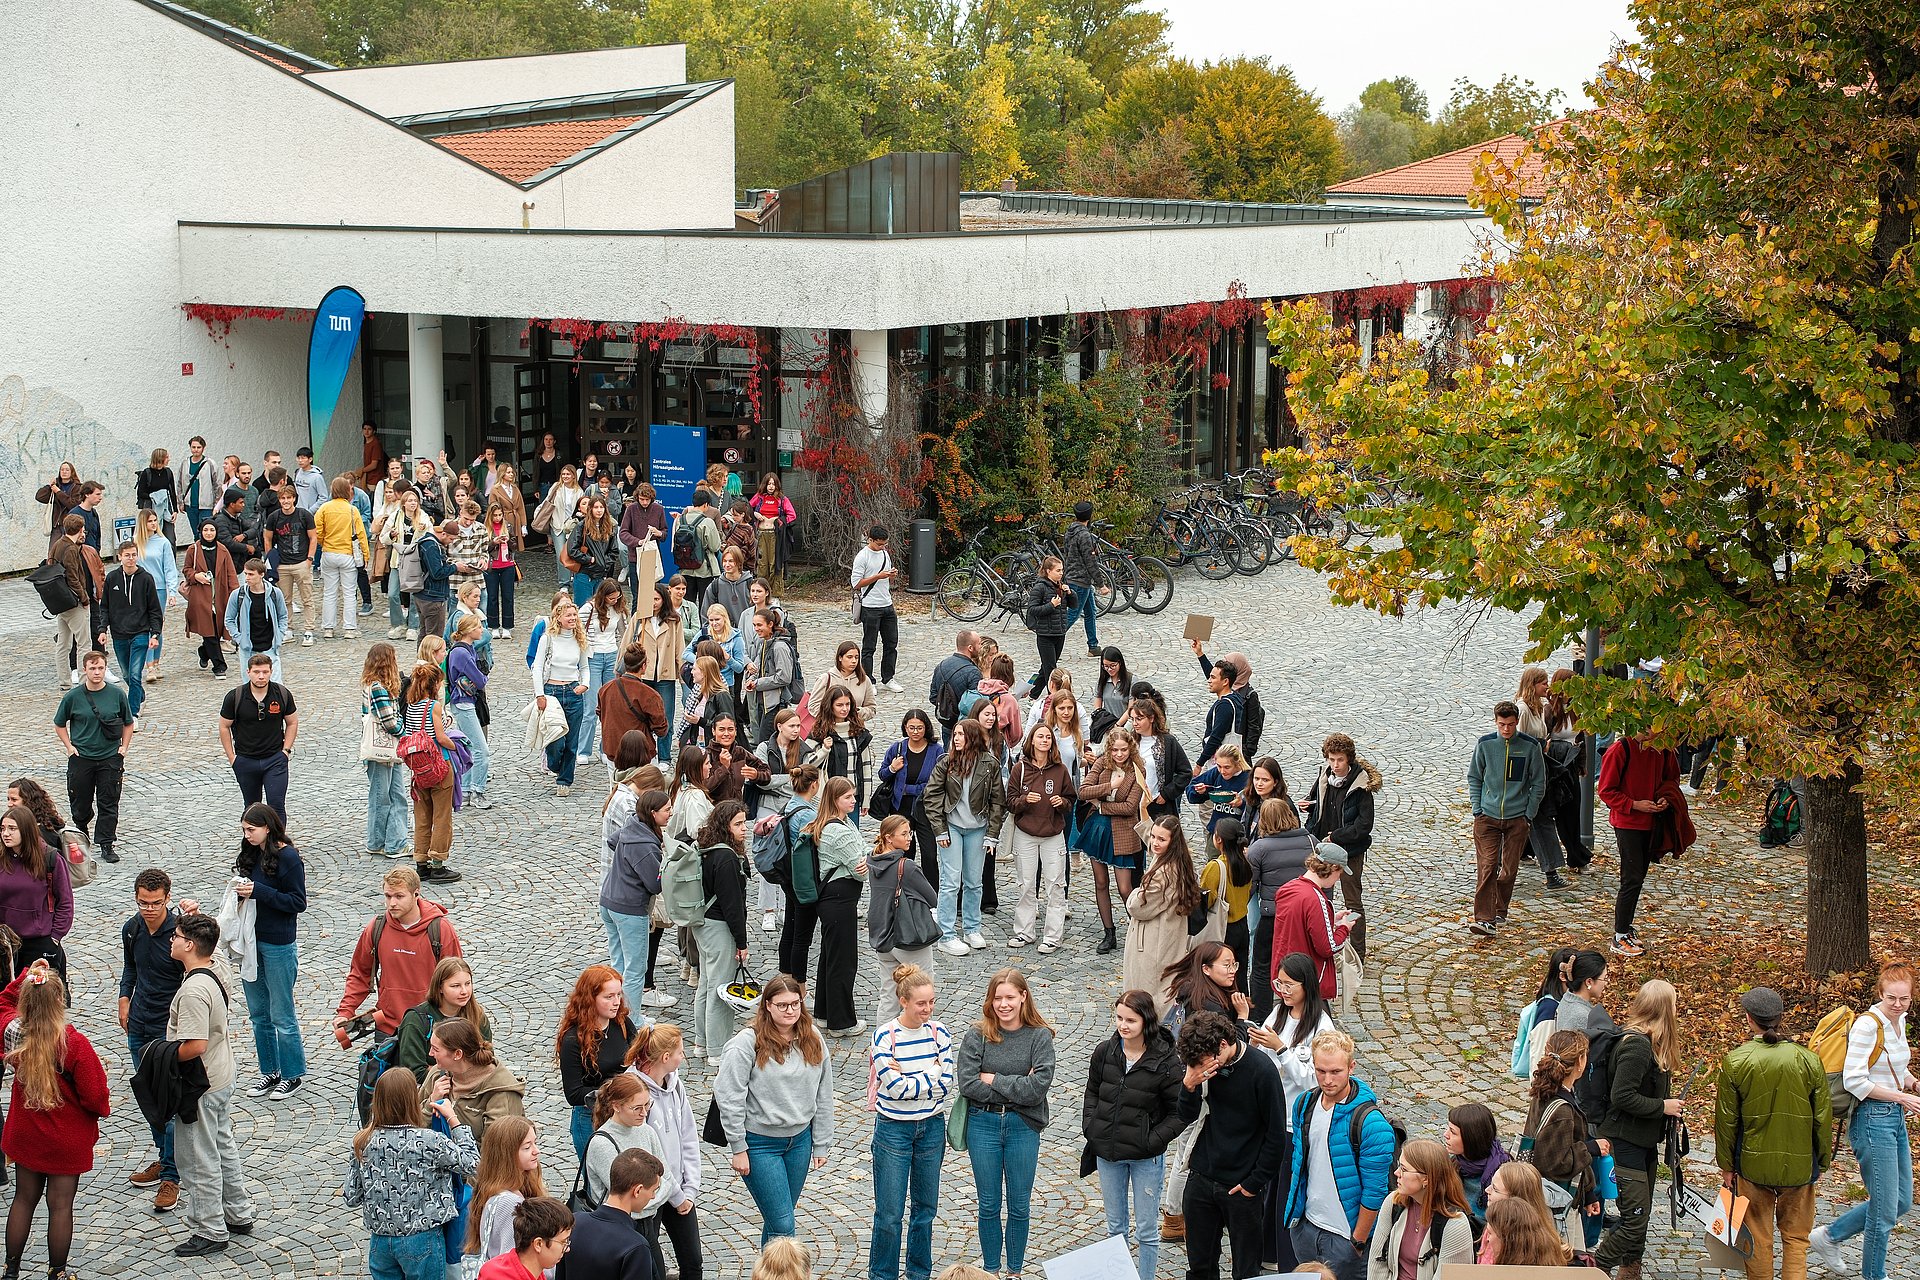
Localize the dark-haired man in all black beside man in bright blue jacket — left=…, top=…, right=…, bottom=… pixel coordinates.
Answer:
left=1179, top=1009, right=1286, bottom=1280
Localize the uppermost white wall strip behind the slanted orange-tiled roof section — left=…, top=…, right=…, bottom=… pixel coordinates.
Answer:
left=307, top=44, right=687, bottom=117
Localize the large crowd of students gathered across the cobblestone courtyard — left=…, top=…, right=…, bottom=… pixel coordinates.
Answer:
left=0, top=432, right=1920, bottom=1280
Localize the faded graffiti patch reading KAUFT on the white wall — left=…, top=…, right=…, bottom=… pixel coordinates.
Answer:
left=0, top=374, right=148, bottom=570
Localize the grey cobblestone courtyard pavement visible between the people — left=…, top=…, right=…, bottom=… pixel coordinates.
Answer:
left=0, top=555, right=1914, bottom=1276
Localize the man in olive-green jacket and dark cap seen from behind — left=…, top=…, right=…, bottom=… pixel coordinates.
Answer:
left=1713, top=986, right=1834, bottom=1280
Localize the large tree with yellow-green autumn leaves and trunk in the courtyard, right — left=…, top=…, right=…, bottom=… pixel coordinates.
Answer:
left=1273, top=0, right=1920, bottom=975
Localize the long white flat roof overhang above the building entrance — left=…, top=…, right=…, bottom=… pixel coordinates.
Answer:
left=179, top=211, right=1492, bottom=330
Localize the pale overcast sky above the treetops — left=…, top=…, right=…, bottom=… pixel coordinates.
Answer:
left=1158, top=0, right=1634, bottom=113
